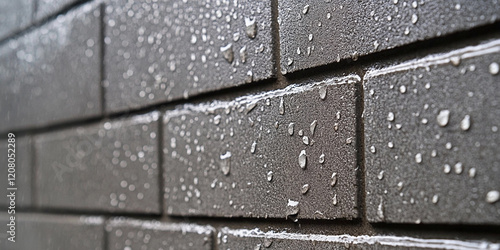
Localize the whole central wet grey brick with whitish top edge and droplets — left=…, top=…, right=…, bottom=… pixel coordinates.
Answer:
left=163, top=75, right=360, bottom=219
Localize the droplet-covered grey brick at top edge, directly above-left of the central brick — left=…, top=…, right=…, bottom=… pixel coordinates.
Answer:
left=104, top=0, right=274, bottom=112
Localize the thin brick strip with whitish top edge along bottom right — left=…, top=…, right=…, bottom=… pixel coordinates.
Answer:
left=217, top=228, right=500, bottom=250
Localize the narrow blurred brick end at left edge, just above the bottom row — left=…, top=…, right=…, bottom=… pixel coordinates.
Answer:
left=0, top=137, right=32, bottom=208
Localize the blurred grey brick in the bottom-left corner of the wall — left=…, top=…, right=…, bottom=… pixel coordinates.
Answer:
left=0, top=213, right=104, bottom=250
